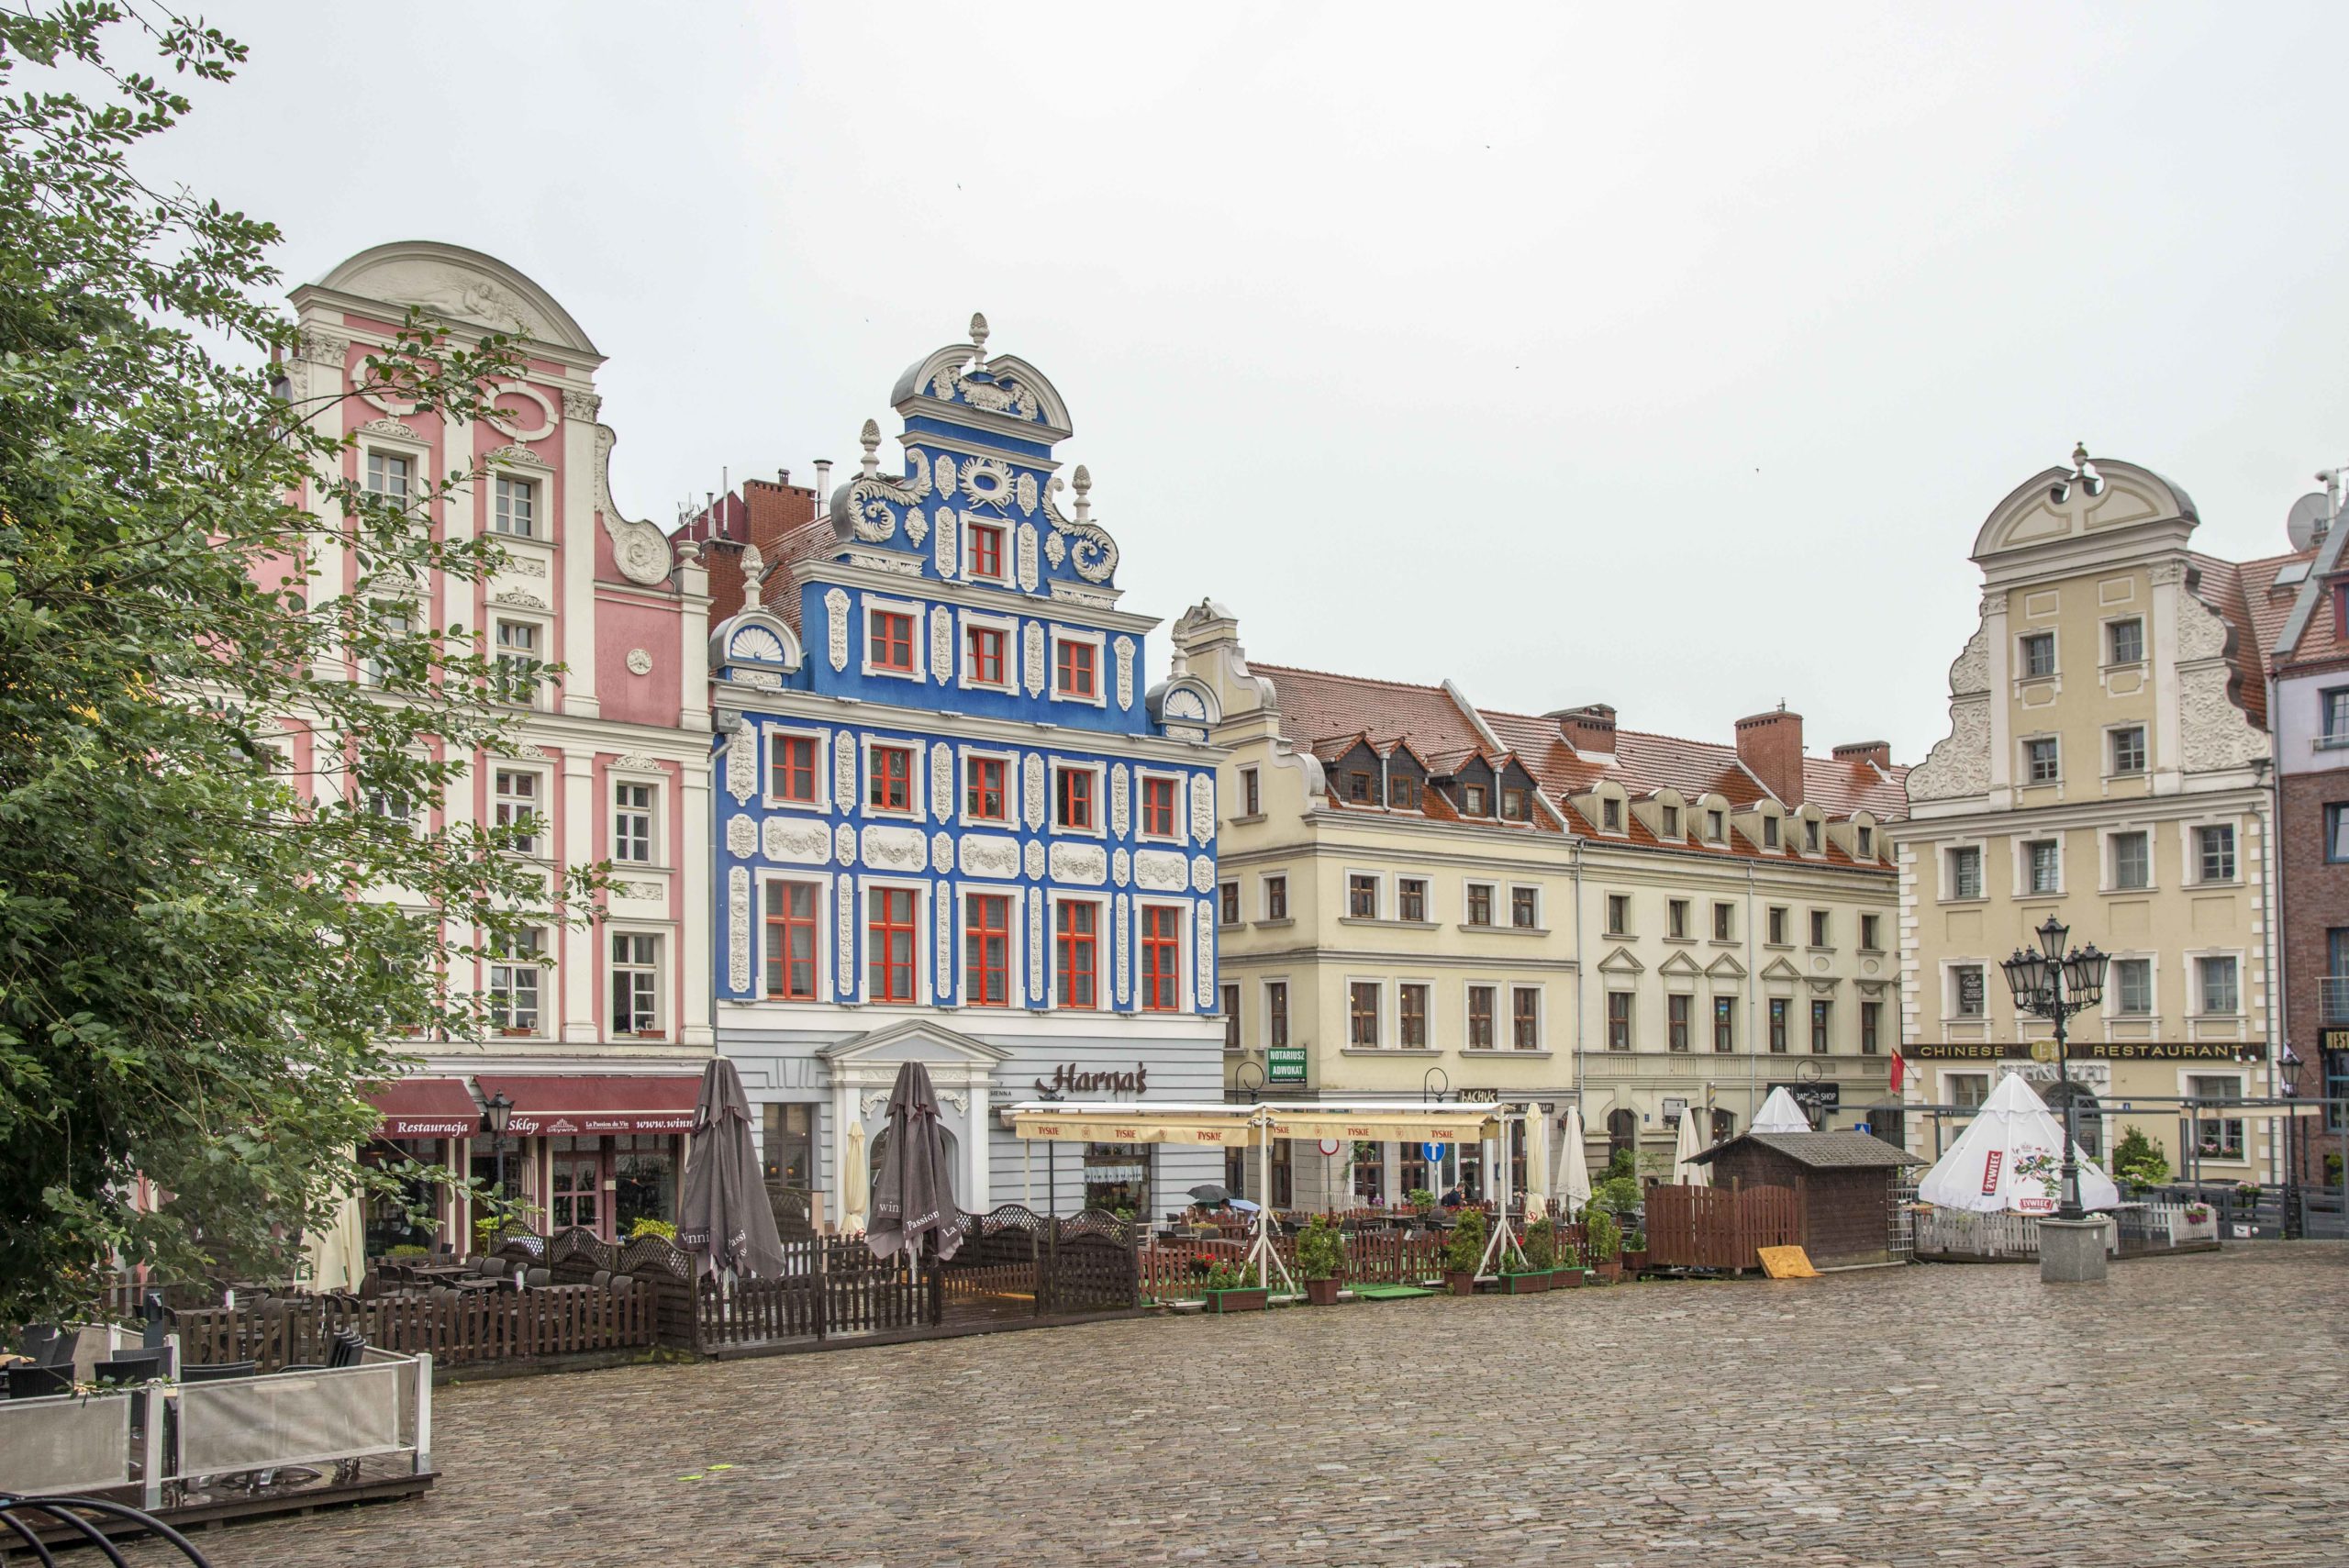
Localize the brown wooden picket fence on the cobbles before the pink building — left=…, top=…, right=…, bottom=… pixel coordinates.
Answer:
left=172, top=1282, right=658, bottom=1371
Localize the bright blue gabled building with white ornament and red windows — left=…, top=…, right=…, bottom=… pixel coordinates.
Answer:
left=707, top=317, right=1224, bottom=1228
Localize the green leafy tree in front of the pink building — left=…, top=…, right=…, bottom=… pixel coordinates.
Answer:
left=0, top=0, right=601, bottom=1321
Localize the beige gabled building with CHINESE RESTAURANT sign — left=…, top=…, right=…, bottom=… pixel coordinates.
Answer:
left=1891, top=453, right=2307, bottom=1181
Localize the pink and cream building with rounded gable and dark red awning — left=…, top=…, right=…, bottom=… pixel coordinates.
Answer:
left=284, top=242, right=712, bottom=1251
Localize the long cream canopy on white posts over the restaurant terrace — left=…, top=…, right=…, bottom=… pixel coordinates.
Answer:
left=1003, top=1101, right=1518, bottom=1294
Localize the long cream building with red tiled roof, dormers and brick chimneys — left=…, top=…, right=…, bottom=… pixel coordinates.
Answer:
left=1174, top=604, right=1900, bottom=1207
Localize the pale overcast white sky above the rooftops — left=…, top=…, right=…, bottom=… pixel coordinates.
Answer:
left=125, top=0, right=2349, bottom=761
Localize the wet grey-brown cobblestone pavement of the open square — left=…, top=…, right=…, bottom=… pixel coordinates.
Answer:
left=141, top=1244, right=2349, bottom=1568
